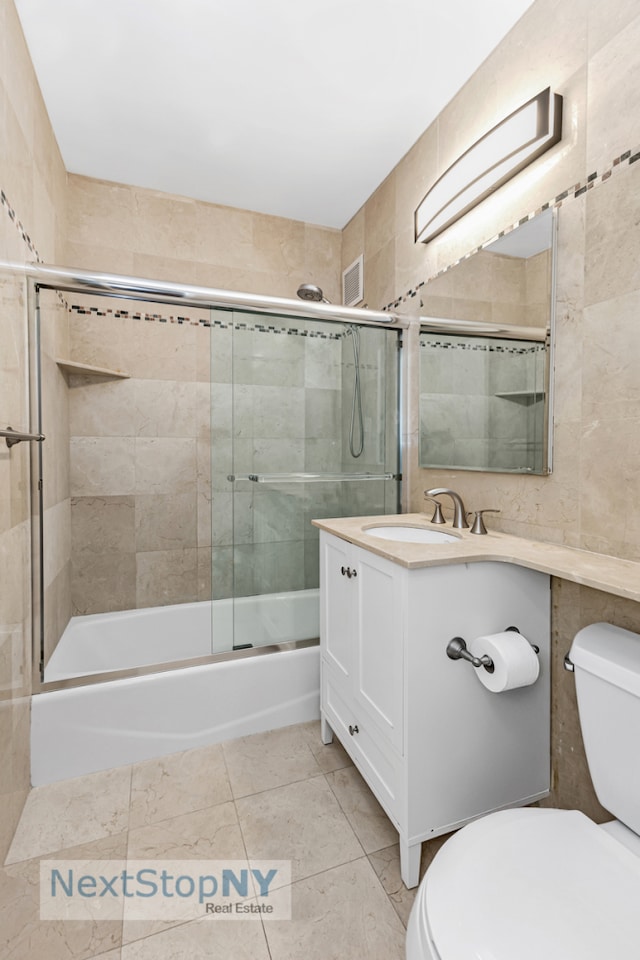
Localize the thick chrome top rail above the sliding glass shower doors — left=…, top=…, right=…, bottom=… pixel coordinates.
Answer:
left=0, top=261, right=409, bottom=329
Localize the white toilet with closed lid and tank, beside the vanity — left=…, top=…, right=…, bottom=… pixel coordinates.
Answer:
left=406, top=623, right=640, bottom=960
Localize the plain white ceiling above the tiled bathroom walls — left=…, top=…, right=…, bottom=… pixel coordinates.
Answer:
left=15, top=0, right=533, bottom=228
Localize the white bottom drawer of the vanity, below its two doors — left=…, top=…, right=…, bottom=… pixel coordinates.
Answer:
left=322, top=664, right=403, bottom=828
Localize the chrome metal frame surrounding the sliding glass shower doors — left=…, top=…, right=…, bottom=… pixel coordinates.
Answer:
left=20, top=263, right=410, bottom=694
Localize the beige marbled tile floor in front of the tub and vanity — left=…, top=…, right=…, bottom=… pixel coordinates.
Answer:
left=0, top=723, right=450, bottom=960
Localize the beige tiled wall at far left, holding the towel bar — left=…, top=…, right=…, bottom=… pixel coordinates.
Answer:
left=0, top=0, right=66, bottom=859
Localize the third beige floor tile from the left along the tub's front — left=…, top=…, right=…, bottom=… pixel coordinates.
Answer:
left=223, top=725, right=322, bottom=798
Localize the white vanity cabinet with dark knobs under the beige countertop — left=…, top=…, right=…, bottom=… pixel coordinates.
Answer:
left=320, top=530, right=550, bottom=887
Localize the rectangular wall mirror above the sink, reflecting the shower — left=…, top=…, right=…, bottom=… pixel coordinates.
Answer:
left=419, top=210, right=555, bottom=474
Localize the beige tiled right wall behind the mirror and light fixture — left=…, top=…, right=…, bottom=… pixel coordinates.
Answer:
left=343, top=0, right=640, bottom=811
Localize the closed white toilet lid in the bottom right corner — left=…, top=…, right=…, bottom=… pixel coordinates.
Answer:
left=423, top=809, right=640, bottom=960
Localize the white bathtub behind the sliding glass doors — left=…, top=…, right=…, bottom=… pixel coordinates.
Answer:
left=31, top=591, right=320, bottom=786
